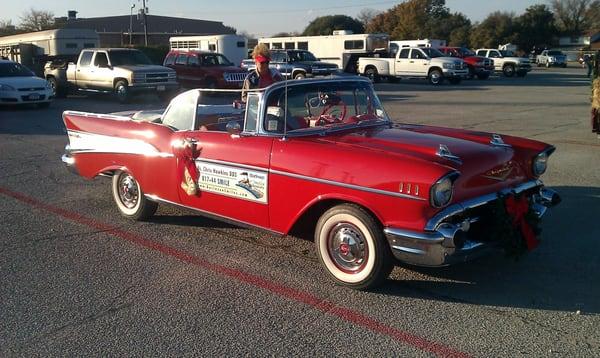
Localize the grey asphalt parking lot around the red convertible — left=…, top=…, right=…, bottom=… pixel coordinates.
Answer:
left=0, top=67, right=600, bottom=357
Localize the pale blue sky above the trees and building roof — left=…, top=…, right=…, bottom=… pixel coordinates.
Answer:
left=0, top=0, right=547, bottom=36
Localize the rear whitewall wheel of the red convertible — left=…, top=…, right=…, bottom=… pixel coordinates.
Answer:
left=112, top=171, right=158, bottom=220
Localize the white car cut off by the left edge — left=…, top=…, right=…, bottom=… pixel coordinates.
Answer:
left=0, top=60, right=54, bottom=107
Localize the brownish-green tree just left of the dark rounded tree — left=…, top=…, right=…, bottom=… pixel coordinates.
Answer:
left=470, top=11, right=517, bottom=48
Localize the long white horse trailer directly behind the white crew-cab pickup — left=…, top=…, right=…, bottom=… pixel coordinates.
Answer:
left=258, top=31, right=390, bottom=73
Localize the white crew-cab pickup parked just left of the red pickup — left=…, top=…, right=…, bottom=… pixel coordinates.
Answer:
left=358, top=47, right=469, bottom=85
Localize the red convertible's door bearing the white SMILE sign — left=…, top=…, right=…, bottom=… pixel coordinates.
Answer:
left=165, top=91, right=274, bottom=228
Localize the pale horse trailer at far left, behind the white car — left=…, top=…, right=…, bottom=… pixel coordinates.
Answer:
left=0, top=29, right=99, bottom=73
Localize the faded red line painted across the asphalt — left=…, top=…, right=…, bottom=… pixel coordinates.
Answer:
left=0, top=187, right=469, bottom=357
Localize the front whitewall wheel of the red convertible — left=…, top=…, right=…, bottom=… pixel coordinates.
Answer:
left=315, top=204, right=394, bottom=290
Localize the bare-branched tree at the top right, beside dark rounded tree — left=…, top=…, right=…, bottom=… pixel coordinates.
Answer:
left=550, top=0, right=592, bottom=35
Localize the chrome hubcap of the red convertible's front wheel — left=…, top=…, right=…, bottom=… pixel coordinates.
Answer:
left=327, top=223, right=368, bottom=273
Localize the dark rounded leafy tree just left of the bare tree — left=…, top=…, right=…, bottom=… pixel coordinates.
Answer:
left=516, top=4, right=558, bottom=52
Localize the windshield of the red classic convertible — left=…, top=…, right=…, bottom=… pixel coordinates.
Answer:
left=263, top=81, right=389, bottom=135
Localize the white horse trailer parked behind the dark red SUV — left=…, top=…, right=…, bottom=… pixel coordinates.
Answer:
left=169, top=35, right=248, bottom=66
